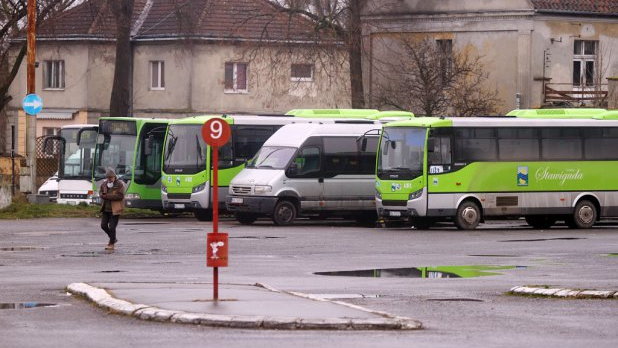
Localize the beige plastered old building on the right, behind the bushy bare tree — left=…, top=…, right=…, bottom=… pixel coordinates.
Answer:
left=362, top=0, right=618, bottom=113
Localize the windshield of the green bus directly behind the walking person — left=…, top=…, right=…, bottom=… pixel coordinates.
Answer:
left=94, top=133, right=136, bottom=180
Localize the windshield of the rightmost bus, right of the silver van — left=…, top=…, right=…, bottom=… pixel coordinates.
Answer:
left=377, top=127, right=427, bottom=180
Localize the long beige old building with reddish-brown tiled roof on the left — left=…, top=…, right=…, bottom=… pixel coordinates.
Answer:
left=8, top=0, right=350, bottom=153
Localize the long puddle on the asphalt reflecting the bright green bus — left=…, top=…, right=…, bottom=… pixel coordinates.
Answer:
left=314, top=265, right=527, bottom=278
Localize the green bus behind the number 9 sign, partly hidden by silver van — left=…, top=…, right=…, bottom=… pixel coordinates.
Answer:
left=161, top=109, right=414, bottom=221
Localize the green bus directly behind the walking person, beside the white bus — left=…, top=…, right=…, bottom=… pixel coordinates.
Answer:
left=93, top=117, right=170, bottom=211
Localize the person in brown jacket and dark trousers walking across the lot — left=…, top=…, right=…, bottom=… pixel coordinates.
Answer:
left=99, top=168, right=125, bottom=250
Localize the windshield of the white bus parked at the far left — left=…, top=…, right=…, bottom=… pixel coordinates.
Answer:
left=59, top=128, right=97, bottom=180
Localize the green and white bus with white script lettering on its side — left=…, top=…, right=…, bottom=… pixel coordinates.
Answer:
left=376, top=111, right=618, bottom=229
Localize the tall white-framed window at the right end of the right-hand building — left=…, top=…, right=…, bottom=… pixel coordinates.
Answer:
left=573, top=40, right=599, bottom=87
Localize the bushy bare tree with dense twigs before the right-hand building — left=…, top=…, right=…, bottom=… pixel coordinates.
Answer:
left=373, top=38, right=499, bottom=116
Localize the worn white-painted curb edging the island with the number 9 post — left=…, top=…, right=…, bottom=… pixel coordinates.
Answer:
left=67, top=283, right=422, bottom=330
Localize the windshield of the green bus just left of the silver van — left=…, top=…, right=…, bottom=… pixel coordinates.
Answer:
left=163, top=125, right=206, bottom=174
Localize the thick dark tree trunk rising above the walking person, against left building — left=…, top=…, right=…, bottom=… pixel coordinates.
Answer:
left=108, top=0, right=133, bottom=117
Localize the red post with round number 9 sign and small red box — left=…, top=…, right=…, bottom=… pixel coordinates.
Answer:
left=202, top=118, right=231, bottom=301
